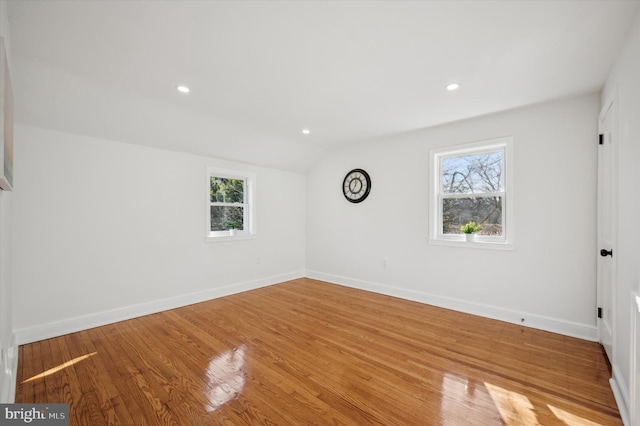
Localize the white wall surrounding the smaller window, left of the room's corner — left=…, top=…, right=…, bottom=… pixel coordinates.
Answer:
left=12, top=125, right=306, bottom=343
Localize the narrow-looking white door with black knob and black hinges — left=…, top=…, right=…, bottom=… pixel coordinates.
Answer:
left=597, top=103, right=617, bottom=361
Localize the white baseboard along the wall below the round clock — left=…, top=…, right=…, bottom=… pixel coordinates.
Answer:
left=306, top=271, right=597, bottom=342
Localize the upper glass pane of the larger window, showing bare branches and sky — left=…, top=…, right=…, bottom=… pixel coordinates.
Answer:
left=442, top=151, right=503, bottom=194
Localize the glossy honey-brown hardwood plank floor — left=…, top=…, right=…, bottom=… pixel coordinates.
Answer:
left=16, top=279, right=622, bottom=426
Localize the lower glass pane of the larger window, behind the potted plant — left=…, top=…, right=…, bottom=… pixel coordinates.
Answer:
left=442, top=197, right=503, bottom=237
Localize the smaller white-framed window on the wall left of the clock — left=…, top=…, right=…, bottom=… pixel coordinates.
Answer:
left=207, top=168, right=255, bottom=241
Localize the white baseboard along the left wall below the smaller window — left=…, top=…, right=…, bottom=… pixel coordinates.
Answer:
left=15, top=271, right=305, bottom=345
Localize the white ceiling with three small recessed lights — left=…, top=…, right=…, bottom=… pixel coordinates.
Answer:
left=8, top=0, right=640, bottom=171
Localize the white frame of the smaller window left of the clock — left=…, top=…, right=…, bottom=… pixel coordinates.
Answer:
left=205, top=167, right=256, bottom=242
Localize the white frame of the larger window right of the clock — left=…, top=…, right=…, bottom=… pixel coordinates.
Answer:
left=428, top=136, right=515, bottom=250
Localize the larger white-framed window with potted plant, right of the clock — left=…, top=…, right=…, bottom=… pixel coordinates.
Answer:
left=429, top=137, right=513, bottom=248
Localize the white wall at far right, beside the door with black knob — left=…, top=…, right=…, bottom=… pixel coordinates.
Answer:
left=602, top=5, right=640, bottom=425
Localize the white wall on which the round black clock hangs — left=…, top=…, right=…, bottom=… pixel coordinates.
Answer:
left=307, top=95, right=600, bottom=339
